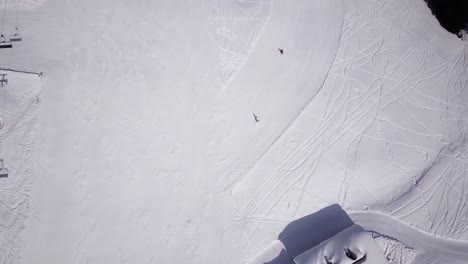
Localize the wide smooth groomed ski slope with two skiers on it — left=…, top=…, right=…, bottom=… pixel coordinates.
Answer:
left=18, top=0, right=343, bottom=263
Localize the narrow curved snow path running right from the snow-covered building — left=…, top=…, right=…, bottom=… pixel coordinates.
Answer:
left=349, top=212, right=468, bottom=260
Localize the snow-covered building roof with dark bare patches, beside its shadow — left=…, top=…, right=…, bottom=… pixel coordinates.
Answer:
left=294, top=225, right=388, bottom=264
